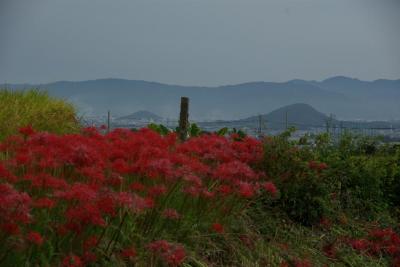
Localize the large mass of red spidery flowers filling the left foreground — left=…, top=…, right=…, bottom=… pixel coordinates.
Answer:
left=0, top=127, right=277, bottom=266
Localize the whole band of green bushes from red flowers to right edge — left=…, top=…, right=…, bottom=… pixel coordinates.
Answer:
left=262, top=131, right=400, bottom=225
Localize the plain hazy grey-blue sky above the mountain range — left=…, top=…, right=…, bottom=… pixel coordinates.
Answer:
left=0, top=0, right=400, bottom=85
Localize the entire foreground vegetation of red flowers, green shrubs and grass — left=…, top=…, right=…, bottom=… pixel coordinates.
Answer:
left=0, top=124, right=400, bottom=266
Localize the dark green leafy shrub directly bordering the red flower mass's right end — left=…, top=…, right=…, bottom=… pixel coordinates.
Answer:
left=263, top=130, right=330, bottom=225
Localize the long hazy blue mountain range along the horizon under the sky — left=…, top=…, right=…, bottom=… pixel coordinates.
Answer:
left=0, top=76, right=400, bottom=120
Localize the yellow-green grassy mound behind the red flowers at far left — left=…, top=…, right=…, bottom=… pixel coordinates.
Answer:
left=0, top=89, right=79, bottom=140
